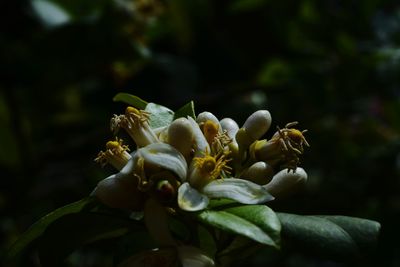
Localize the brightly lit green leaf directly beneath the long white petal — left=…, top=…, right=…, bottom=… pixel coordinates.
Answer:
left=197, top=205, right=281, bottom=248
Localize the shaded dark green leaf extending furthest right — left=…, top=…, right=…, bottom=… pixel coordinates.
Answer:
left=278, top=213, right=380, bottom=258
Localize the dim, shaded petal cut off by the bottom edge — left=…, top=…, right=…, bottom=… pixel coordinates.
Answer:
left=178, top=246, right=215, bottom=267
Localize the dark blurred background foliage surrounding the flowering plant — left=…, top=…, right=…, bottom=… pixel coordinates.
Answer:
left=0, top=0, right=400, bottom=266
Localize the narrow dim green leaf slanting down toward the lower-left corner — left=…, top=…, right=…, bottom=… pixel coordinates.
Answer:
left=7, top=197, right=97, bottom=260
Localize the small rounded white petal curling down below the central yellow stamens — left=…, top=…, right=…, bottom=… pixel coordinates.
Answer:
left=178, top=183, right=209, bottom=211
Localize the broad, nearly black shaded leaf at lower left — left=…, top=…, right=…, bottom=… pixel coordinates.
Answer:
left=39, top=212, right=145, bottom=266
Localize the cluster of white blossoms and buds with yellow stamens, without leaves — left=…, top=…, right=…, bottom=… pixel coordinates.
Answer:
left=92, top=107, right=309, bottom=266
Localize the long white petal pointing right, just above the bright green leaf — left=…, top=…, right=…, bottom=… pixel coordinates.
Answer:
left=202, top=178, right=274, bottom=204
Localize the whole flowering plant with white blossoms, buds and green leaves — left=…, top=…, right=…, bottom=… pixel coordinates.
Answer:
left=9, top=93, right=380, bottom=267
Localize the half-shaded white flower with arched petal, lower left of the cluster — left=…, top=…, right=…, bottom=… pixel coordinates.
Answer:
left=92, top=143, right=187, bottom=210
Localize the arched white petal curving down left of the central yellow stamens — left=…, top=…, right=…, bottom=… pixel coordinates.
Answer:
left=135, top=143, right=187, bottom=181
